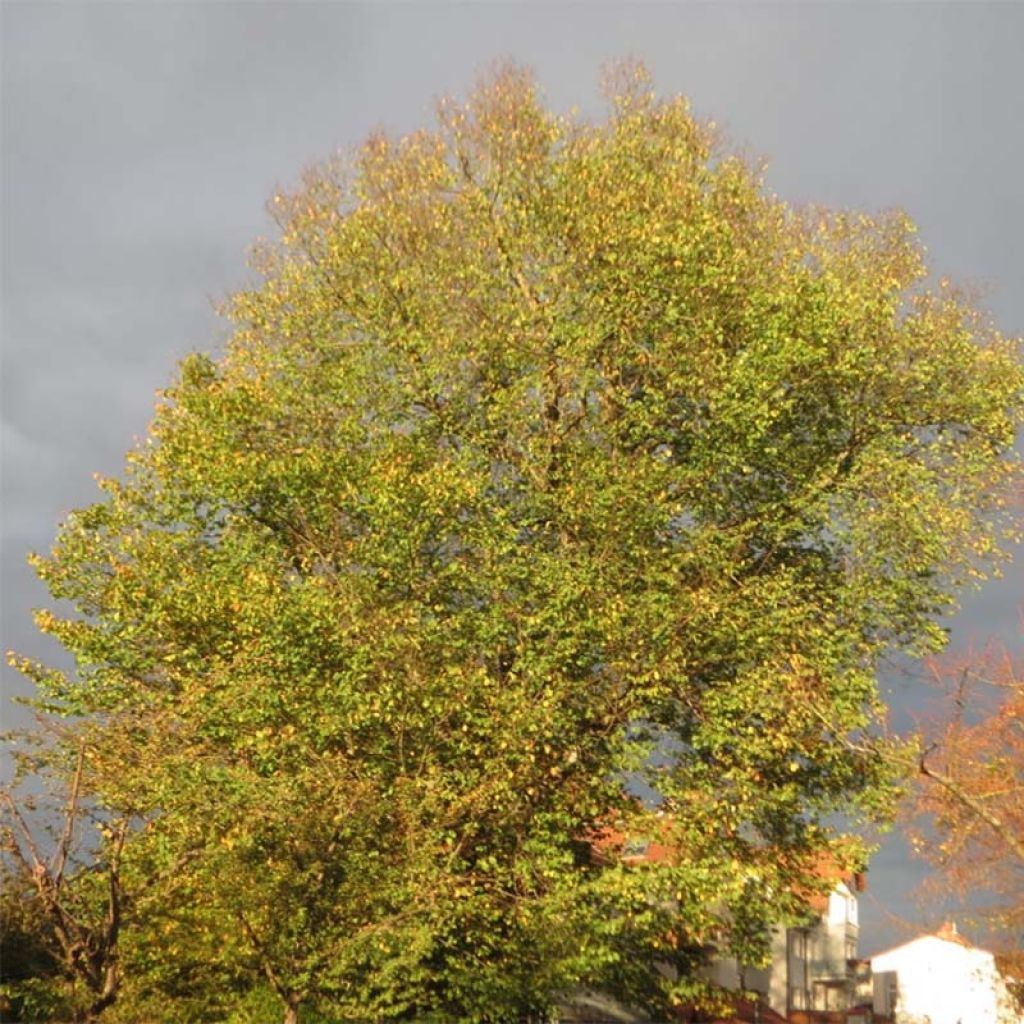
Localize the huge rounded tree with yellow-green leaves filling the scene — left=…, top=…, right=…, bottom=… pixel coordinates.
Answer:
left=9, top=68, right=1022, bottom=1020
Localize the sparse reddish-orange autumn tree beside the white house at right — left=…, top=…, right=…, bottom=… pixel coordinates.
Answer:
left=910, top=626, right=1024, bottom=948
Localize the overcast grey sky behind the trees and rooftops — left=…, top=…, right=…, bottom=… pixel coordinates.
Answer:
left=0, top=0, right=1024, bottom=953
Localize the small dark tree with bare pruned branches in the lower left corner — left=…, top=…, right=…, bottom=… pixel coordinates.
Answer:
left=0, top=723, right=214, bottom=1024
